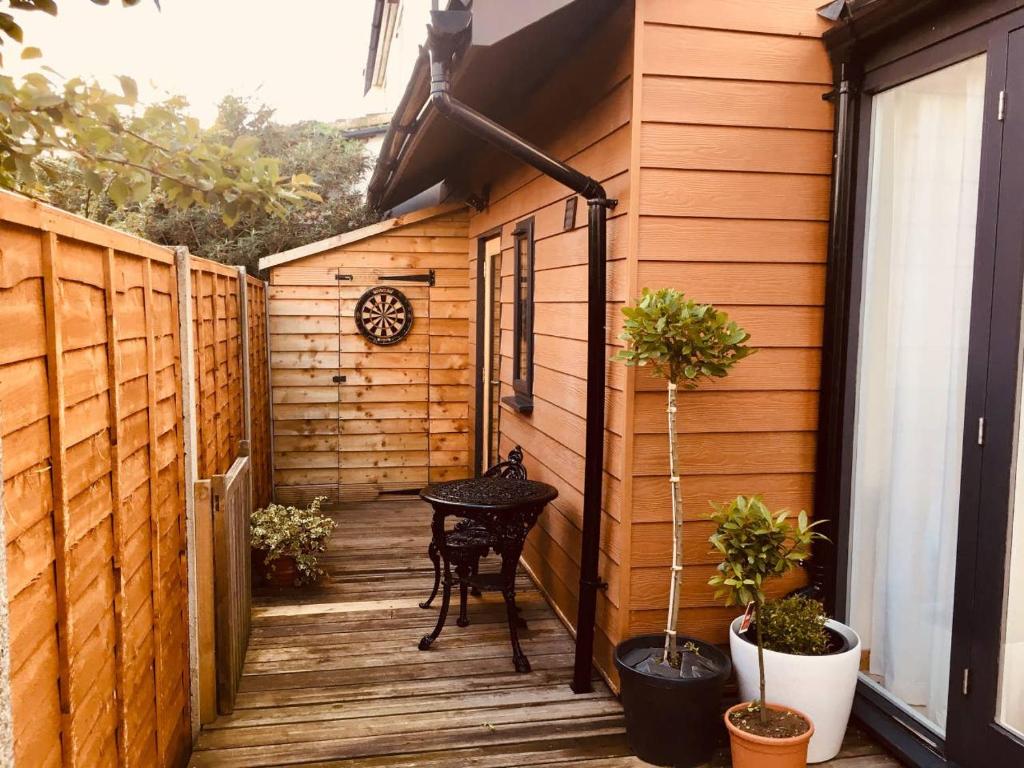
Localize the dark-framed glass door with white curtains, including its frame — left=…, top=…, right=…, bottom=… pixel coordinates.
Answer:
left=840, top=11, right=1024, bottom=766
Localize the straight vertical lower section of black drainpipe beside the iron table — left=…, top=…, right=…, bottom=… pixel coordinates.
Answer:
left=572, top=199, right=608, bottom=693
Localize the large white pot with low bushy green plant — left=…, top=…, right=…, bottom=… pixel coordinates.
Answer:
left=729, top=595, right=860, bottom=763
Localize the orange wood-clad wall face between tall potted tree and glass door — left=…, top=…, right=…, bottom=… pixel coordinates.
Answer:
left=628, top=0, right=831, bottom=642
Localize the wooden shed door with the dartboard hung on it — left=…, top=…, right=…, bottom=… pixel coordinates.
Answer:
left=338, top=268, right=430, bottom=500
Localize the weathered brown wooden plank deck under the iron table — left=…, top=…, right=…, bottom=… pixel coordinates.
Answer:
left=190, top=498, right=897, bottom=768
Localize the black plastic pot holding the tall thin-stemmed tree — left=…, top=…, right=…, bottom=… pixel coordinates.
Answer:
left=615, top=635, right=732, bottom=768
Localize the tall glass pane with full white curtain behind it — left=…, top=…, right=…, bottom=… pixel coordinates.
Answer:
left=849, top=56, right=985, bottom=732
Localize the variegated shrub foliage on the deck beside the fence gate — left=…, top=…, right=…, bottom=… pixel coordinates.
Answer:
left=249, top=496, right=335, bottom=584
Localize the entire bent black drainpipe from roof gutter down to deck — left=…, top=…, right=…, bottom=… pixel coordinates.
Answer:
left=427, top=10, right=616, bottom=693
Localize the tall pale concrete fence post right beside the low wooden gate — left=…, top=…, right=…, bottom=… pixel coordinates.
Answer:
left=174, top=246, right=200, bottom=744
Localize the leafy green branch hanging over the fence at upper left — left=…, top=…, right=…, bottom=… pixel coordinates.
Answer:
left=0, top=67, right=321, bottom=225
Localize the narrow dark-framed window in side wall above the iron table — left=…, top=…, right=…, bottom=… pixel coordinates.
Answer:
left=505, top=218, right=534, bottom=414
